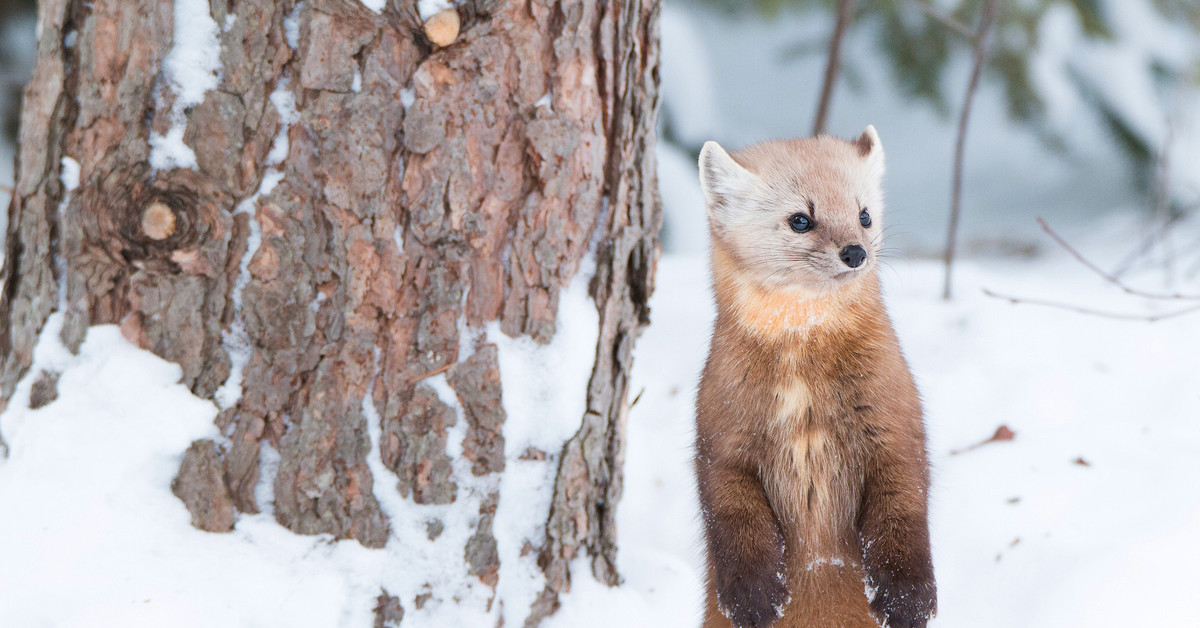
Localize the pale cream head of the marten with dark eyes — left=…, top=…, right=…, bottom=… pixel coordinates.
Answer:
left=700, top=126, right=883, bottom=295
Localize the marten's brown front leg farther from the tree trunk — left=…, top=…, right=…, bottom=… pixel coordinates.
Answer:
left=858, top=435, right=937, bottom=628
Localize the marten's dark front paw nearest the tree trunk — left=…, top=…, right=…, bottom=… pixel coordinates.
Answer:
left=716, top=562, right=791, bottom=628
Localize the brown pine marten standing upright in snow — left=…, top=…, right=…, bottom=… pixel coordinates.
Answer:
left=696, top=126, right=937, bottom=628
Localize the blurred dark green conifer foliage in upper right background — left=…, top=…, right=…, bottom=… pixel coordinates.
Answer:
left=686, top=0, right=1200, bottom=201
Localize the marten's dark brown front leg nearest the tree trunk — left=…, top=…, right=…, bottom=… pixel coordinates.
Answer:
left=697, top=457, right=788, bottom=628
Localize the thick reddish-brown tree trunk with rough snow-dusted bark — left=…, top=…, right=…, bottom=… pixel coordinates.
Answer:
left=0, top=0, right=661, bottom=624
